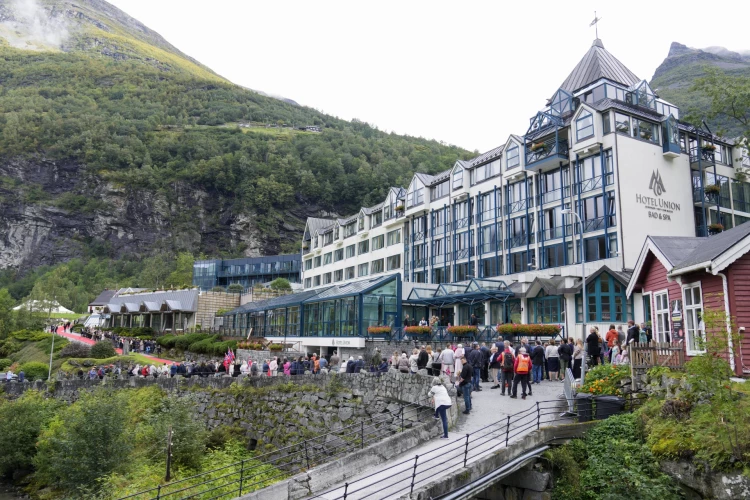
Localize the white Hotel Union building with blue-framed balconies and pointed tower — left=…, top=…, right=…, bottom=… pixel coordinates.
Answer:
left=226, top=40, right=750, bottom=352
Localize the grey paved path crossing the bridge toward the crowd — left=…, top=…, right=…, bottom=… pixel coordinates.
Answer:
left=310, top=381, right=563, bottom=500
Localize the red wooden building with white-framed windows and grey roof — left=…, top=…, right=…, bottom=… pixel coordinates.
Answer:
left=627, top=224, right=750, bottom=376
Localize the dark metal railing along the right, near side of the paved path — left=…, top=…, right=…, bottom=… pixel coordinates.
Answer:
left=308, top=396, right=640, bottom=500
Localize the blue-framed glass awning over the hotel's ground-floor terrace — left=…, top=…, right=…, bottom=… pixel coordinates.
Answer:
left=405, top=278, right=514, bottom=307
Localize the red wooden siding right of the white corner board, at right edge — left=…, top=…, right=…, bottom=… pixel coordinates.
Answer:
left=726, top=254, right=750, bottom=376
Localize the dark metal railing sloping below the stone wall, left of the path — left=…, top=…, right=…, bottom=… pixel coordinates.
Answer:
left=119, top=392, right=434, bottom=500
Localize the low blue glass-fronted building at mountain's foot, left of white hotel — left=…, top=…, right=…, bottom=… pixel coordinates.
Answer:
left=193, top=254, right=307, bottom=290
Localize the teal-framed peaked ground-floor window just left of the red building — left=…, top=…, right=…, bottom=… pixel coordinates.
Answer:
left=576, top=273, right=633, bottom=323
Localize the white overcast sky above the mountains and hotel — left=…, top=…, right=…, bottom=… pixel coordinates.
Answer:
left=109, top=0, right=750, bottom=152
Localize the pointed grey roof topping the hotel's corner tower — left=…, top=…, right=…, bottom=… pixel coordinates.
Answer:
left=560, top=38, right=640, bottom=94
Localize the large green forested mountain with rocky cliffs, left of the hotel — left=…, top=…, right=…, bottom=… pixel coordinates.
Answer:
left=0, top=0, right=472, bottom=270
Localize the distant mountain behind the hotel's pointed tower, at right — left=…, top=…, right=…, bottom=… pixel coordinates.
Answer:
left=651, top=42, right=750, bottom=137
